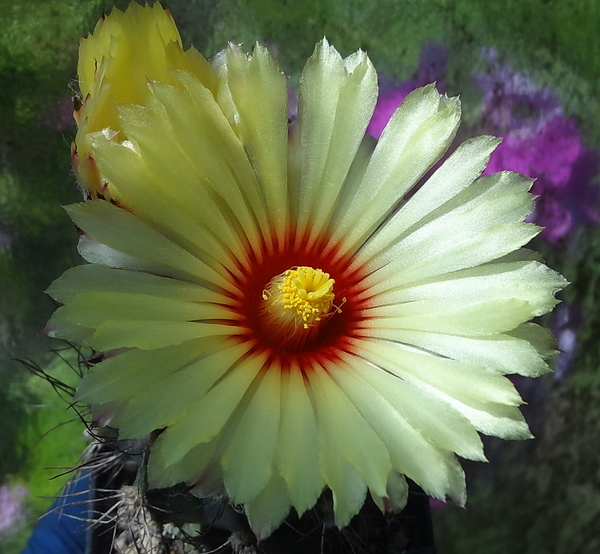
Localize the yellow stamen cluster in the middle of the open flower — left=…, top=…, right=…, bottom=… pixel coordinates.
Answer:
left=263, top=266, right=335, bottom=329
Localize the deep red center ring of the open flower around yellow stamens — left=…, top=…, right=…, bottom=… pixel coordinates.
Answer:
left=226, top=230, right=365, bottom=369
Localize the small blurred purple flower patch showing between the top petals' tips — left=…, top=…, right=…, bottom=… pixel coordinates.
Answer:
left=367, top=43, right=448, bottom=138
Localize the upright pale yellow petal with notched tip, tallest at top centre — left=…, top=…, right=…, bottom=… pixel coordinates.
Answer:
left=292, top=39, right=377, bottom=243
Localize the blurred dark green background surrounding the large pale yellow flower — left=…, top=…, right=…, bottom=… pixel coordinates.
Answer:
left=0, top=0, right=600, bottom=554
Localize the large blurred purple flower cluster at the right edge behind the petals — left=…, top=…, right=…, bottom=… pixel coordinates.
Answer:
left=475, top=49, right=600, bottom=243
